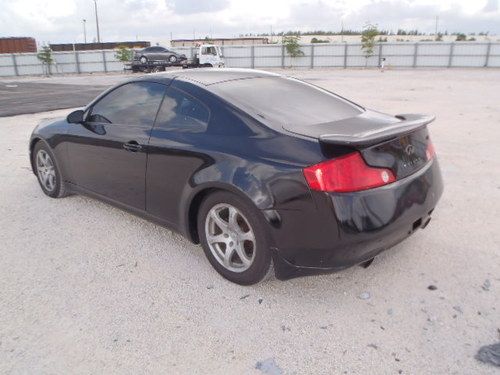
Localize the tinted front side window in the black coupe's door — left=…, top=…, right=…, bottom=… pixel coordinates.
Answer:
left=87, top=82, right=165, bottom=126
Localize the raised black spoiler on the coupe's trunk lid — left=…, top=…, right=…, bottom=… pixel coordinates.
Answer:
left=318, top=114, right=435, bottom=148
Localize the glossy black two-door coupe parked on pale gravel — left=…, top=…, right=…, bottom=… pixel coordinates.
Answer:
left=29, top=69, right=443, bottom=284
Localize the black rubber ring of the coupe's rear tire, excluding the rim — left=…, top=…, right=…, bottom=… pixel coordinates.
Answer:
left=197, top=191, right=272, bottom=285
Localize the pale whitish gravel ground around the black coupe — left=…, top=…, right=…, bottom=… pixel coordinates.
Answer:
left=0, top=70, right=500, bottom=375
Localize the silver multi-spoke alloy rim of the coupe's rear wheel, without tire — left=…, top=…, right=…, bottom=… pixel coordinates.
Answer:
left=205, top=203, right=256, bottom=272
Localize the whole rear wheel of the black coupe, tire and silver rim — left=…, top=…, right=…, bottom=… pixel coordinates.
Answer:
left=197, top=191, right=273, bottom=285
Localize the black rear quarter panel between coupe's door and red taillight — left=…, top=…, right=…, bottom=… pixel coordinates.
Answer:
left=146, top=80, right=323, bottom=241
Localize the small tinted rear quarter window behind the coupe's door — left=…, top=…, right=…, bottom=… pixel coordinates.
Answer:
left=155, top=88, right=210, bottom=133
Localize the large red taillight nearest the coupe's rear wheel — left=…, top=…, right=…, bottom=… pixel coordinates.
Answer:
left=304, top=152, right=396, bottom=192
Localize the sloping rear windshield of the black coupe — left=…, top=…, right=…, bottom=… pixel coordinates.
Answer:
left=212, top=77, right=364, bottom=127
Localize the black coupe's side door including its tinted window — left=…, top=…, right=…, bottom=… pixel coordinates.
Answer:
left=68, top=81, right=166, bottom=210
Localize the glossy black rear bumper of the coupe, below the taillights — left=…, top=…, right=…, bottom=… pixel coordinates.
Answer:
left=273, top=159, right=443, bottom=279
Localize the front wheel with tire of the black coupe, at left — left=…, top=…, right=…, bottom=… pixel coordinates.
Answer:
left=33, top=141, right=69, bottom=198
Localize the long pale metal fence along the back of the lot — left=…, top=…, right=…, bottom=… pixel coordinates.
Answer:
left=0, top=42, right=500, bottom=76
